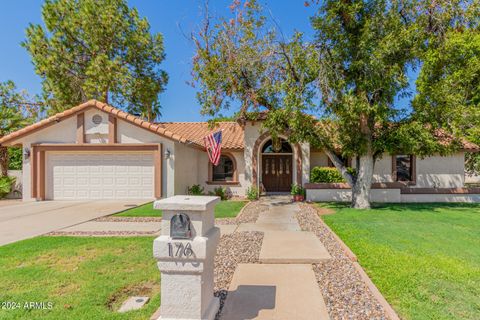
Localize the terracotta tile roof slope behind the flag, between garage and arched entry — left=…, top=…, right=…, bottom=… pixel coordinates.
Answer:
left=158, top=121, right=244, bottom=150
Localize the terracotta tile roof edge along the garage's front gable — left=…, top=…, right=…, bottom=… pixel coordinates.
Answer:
left=0, top=100, right=189, bottom=145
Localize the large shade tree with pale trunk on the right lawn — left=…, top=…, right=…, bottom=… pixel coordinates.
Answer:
left=193, top=0, right=476, bottom=208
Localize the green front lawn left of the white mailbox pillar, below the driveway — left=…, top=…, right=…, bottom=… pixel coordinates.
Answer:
left=0, top=237, right=160, bottom=320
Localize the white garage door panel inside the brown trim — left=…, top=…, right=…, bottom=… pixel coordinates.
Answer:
left=47, top=152, right=155, bottom=200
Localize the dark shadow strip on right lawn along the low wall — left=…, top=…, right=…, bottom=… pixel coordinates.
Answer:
left=318, top=202, right=480, bottom=212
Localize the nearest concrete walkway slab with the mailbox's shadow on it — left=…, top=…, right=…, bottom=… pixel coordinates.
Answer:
left=221, top=264, right=330, bottom=320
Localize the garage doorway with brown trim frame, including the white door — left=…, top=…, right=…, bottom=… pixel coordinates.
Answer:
left=31, top=144, right=162, bottom=200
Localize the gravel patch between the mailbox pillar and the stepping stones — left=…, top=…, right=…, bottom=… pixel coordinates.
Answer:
left=214, top=232, right=263, bottom=320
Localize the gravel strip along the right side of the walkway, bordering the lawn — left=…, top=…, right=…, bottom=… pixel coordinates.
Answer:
left=297, top=204, right=388, bottom=319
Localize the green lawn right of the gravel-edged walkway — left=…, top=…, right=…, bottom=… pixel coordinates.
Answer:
left=323, top=204, right=480, bottom=320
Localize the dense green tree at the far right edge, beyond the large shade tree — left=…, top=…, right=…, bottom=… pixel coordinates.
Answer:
left=414, top=26, right=480, bottom=174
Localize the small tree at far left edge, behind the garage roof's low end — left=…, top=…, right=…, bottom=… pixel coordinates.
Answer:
left=0, top=81, right=40, bottom=176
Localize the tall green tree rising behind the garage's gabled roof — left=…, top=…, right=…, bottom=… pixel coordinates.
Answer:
left=23, top=0, right=168, bottom=121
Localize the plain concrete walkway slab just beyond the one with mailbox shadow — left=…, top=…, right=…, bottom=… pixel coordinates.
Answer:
left=260, top=231, right=331, bottom=263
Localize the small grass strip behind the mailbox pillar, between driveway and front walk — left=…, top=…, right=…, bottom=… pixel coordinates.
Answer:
left=115, top=200, right=247, bottom=218
